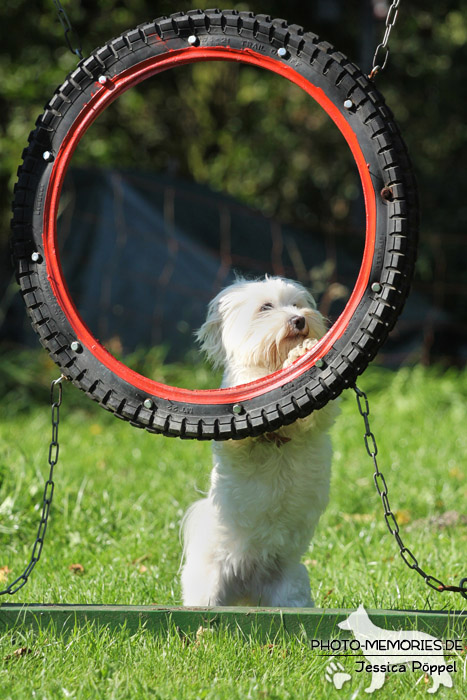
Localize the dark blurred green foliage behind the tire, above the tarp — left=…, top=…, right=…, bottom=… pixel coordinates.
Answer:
left=0, top=0, right=467, bottom=366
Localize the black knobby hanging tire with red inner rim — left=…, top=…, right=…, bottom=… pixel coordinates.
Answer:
left=12, top=10, right=418, bottom=440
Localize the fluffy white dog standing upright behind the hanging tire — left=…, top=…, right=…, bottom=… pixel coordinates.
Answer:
left=182, top=277, right=337, bottom=607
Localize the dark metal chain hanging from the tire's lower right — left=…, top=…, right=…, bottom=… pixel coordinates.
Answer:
left=352, top=384, right=467, bottom=600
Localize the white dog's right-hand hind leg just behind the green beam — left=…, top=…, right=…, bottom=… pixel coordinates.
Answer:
left=260, top=562, right=314, bottom=608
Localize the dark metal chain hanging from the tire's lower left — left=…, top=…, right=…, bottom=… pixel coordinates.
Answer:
left=0, top=375, right=65, bottom=595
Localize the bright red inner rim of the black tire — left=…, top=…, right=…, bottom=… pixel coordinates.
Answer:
left=43, top=46, right=376, bottom=404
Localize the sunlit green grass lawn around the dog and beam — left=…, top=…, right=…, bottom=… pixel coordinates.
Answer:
left=0, top=353, right=467, bottom=700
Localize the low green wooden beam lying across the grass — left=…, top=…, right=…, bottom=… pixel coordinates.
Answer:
left=0, top=603, right=467, bottom=639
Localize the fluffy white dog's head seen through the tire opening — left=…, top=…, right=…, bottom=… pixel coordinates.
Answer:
left=197, top=277, right=326, bottom=373
